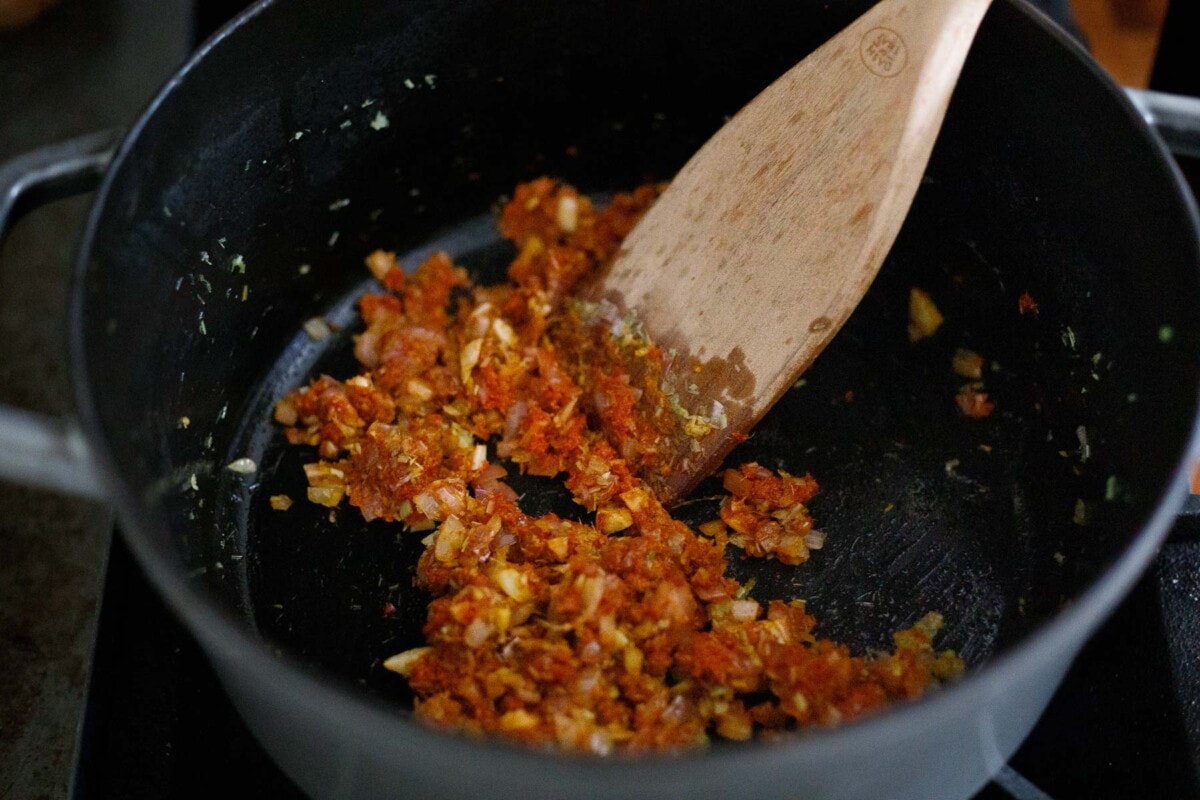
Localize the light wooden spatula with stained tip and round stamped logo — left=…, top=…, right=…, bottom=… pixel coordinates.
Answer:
left=588, top=0, right=990, bottom=501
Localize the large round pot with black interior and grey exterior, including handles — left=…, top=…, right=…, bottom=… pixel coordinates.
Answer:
left=0, top=0, right=1200, bottom=799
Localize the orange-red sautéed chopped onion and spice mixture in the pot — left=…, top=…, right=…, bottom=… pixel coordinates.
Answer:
left=275, top=179, right=962, bottom=753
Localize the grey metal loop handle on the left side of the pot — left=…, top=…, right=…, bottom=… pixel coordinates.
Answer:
left=0, top=131, right=121, bottom=499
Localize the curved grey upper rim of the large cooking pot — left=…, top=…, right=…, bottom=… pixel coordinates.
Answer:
left=70, top=0, right=1200, bottom=788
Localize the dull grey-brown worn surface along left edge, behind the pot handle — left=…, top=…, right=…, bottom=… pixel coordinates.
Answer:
left=0, top=0, right=192, bottom=800
